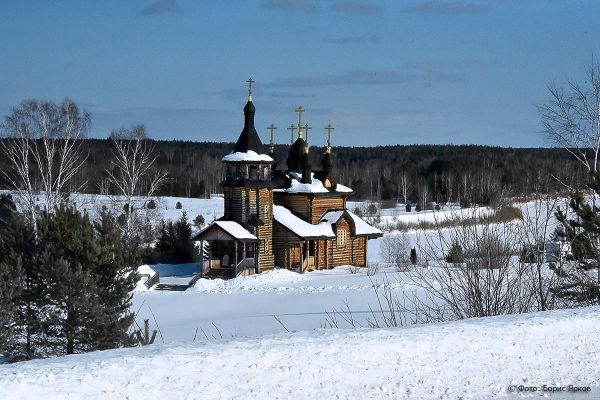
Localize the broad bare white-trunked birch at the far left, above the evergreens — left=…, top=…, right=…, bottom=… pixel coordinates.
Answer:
left=0, top=99, right=91, bottom=227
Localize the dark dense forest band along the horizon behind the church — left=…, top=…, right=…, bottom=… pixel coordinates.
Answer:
left=0, top=139, right=587, bottom=207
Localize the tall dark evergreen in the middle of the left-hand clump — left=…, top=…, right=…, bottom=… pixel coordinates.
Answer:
left=38, top=204, right=103, bottom=355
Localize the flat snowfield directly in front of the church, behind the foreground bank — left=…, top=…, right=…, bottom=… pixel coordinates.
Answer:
left=133, top=267, right=416, bottom=342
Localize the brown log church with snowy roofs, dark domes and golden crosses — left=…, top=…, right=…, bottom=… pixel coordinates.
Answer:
left=193, top=79, right=382, bottom=277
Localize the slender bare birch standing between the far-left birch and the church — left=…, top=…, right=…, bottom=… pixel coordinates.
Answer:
left=107, top=125, right=167, bottom=244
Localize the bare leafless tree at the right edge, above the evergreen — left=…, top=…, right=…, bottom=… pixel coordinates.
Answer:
left=539, top=59, right=600, bottom=173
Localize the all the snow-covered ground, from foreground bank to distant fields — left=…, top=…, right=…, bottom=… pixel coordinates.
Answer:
left=0, top=195, right=600, bottom=399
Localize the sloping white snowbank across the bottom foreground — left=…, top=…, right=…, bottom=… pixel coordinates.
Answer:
left=0, top=307, right=600, bottom=400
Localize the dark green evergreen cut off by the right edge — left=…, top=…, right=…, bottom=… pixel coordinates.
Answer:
left=552, top=171, right=600, bottom=304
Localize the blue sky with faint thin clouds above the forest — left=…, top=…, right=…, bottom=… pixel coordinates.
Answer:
left=0, top=0, right=600, bottom=147
